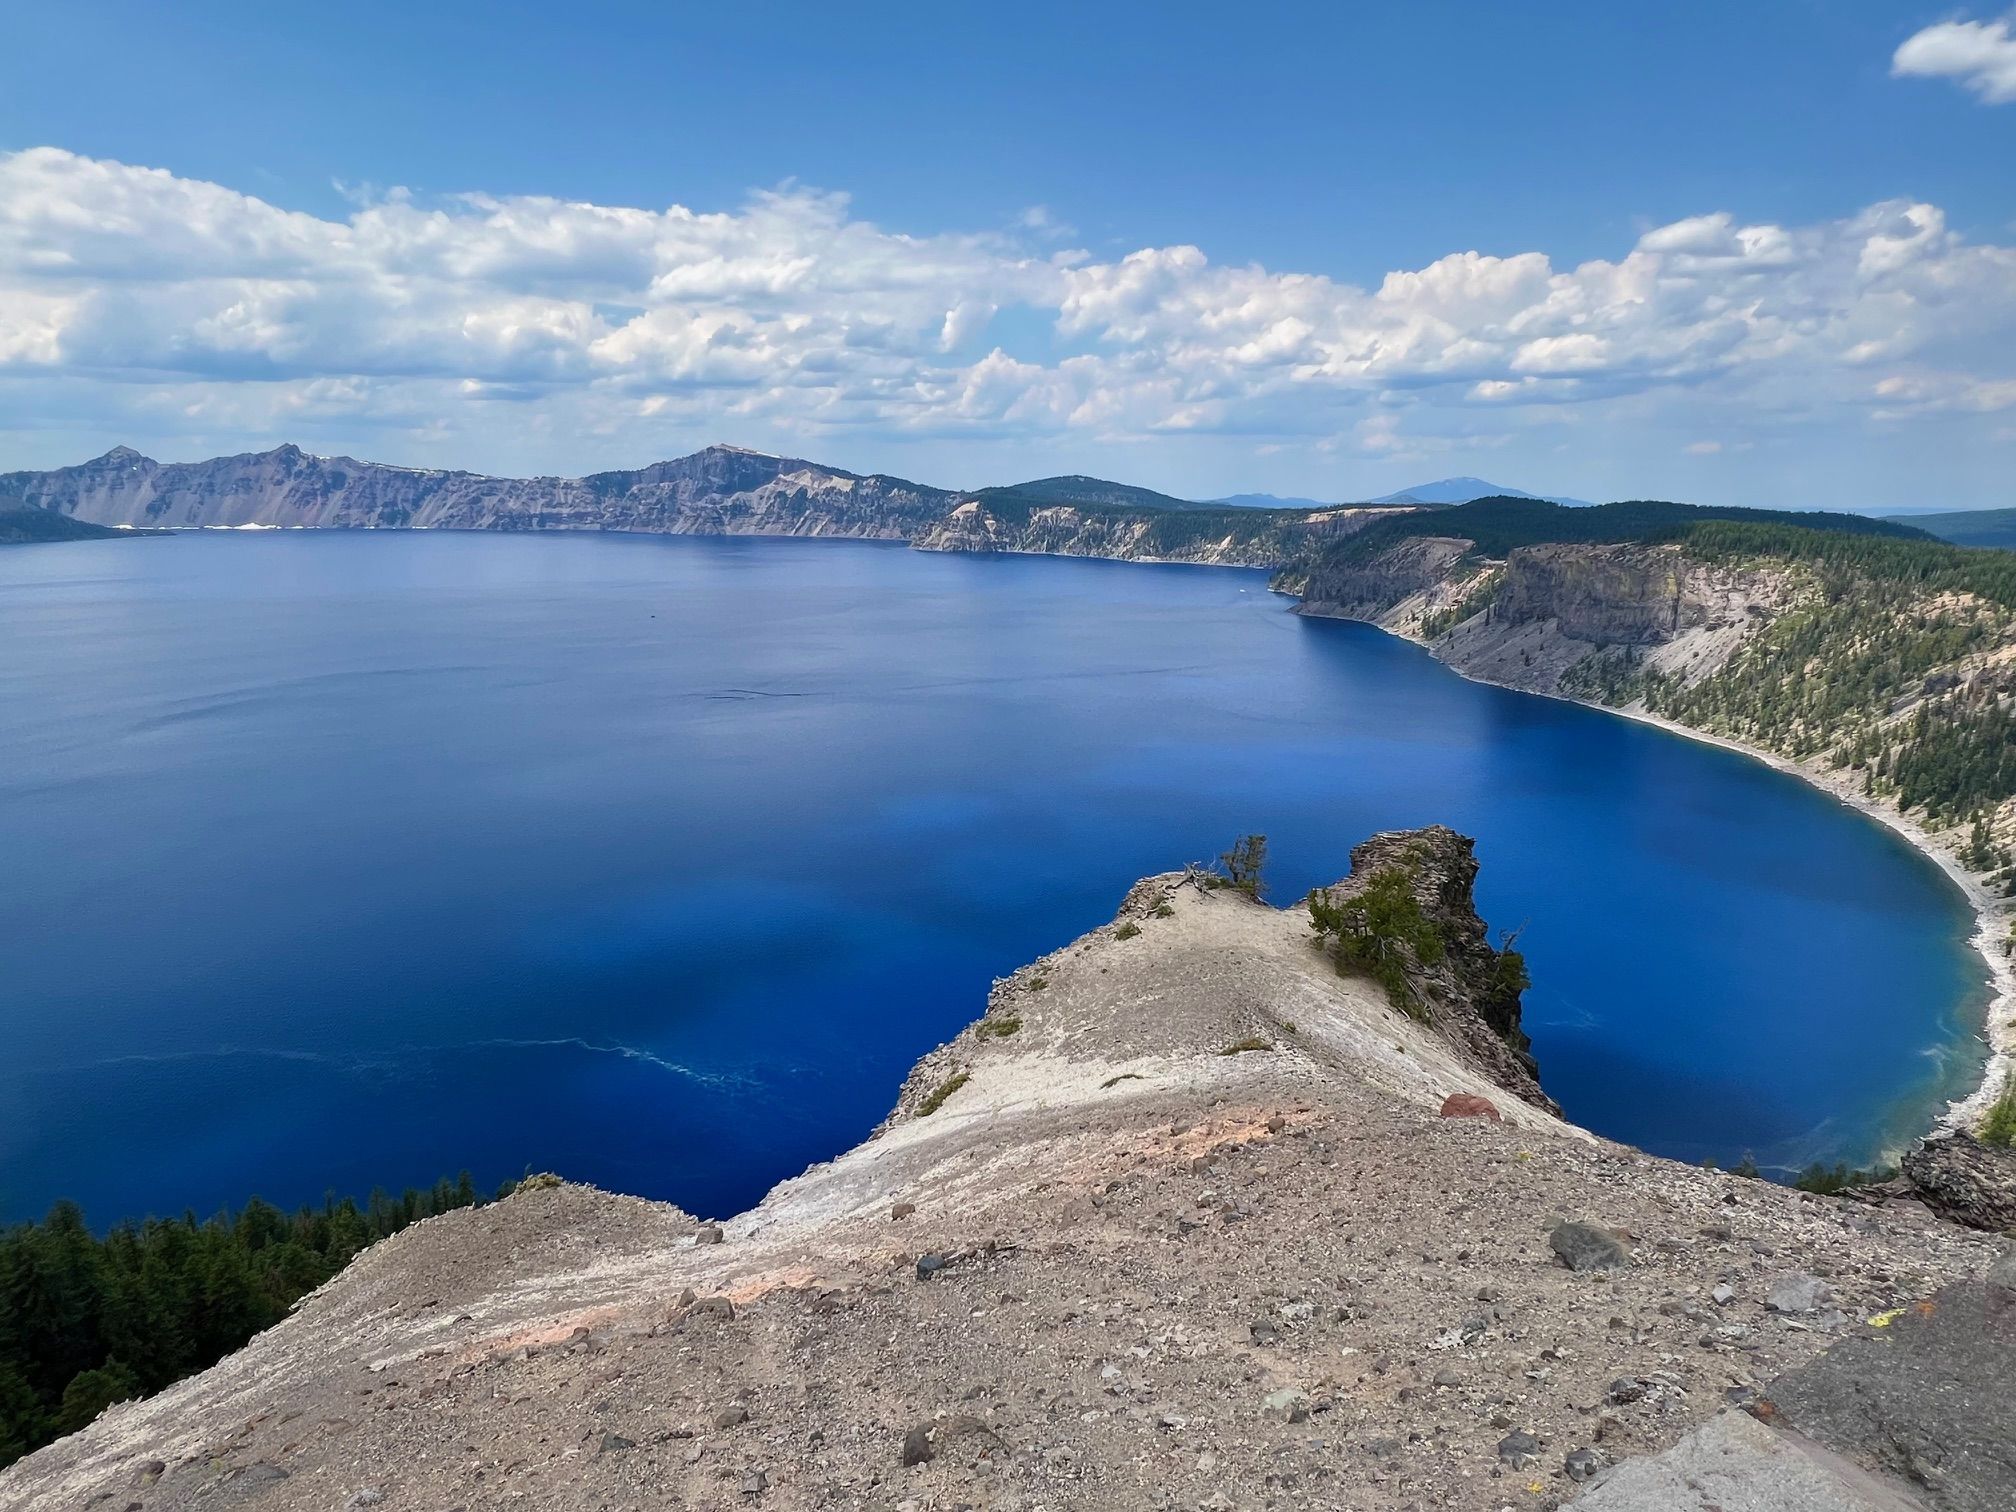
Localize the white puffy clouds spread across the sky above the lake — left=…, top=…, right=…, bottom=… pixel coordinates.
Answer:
left=0, top=147, right=2016, bottom=493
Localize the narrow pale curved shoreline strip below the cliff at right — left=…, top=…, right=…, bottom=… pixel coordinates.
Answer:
left=1282, top=593, right=2016, bottom=1137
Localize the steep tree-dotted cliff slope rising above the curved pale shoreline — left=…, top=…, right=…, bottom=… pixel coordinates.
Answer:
left=1276, top=516, right=2016, bottom=895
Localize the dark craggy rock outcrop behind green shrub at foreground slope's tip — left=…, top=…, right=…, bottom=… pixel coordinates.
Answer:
left=1322, top=825, right=1560, bottom=1113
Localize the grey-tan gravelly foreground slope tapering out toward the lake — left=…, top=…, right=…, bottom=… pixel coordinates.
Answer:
left=0, top=831, right=2016, bottom=1512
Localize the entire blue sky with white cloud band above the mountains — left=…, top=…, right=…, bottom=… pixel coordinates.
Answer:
left=0, top=2, right=2016, bottom=506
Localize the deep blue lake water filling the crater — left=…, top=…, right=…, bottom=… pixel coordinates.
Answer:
left=0, top=534, right=1986, bottom=1224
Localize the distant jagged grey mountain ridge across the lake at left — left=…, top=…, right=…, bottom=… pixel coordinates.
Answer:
left=0, top=446, right=956, bottom=540
